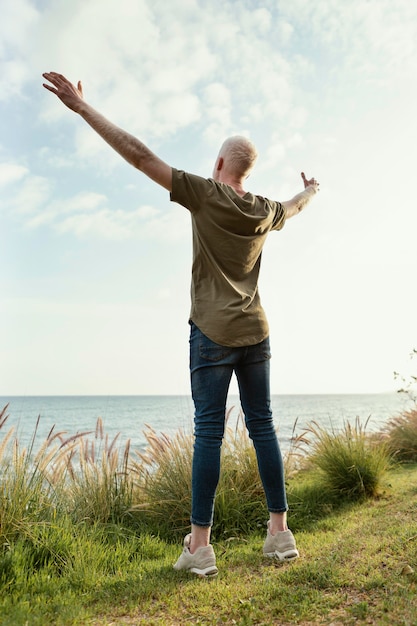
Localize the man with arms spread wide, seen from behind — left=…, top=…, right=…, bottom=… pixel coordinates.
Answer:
left=43, top=72, right=318, bottom=576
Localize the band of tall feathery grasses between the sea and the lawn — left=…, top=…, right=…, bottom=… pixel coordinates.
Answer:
left=0, top=407, right=417, bottom=546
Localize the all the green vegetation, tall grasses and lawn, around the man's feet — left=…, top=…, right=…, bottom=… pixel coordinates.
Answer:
left=0, top=394, right=417, bottom=626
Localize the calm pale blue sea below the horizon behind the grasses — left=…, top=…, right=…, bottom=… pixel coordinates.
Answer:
left=0, top=393, right=414, bottom=451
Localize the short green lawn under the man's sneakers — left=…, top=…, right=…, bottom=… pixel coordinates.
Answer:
left=0, top=466, right=417, bottom=626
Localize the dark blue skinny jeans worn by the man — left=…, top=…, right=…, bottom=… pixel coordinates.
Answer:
left=190, top=322, right=288, bottom=526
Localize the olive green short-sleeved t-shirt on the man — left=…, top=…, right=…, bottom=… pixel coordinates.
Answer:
left=171, top=169, right=285, bottom=346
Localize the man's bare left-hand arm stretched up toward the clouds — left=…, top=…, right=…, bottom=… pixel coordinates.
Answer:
left=43, top=72, right=172, bottom=191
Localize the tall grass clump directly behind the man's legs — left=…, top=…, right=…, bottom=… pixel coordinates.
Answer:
left=133, top=411, right=266, bottom=537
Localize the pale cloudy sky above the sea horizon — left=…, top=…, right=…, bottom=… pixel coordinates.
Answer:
left=0, top=0, right=417, bottom=395
